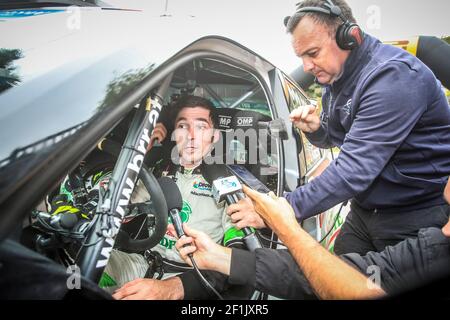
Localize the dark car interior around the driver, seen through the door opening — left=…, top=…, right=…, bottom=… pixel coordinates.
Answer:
left=21, top=58, right=279, bottom=299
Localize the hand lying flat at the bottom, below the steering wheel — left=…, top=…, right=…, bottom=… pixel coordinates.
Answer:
left=113, top=277, right=184, bottom=300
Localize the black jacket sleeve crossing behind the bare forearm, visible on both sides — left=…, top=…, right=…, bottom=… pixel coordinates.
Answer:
left=229, top=228, right=450, bottom=299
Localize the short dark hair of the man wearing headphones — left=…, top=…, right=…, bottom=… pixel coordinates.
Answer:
left=286, top=0, right=356, bottom=37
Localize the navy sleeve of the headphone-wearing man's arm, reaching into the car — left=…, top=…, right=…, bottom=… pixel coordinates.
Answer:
left=286, top=62, right=427, bottom=220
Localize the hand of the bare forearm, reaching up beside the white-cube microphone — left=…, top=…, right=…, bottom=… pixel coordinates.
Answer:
left=243, top=185, right=299, bottom=240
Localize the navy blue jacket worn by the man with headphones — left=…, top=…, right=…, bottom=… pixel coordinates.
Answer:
left=286, top=35, right=450, bottom=220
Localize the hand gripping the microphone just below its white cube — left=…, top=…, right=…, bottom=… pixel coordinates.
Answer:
left=227, top=198, right=266, bottom=230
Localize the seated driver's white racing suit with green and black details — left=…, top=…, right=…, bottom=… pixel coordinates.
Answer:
left=100, top=165, right=244, bottom=299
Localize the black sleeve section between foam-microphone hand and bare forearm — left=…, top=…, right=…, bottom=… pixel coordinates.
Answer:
left=229, top=248, right=314, bottom=299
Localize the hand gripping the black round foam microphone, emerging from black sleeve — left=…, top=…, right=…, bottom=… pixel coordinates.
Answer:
left=175, top=224, right=231, bottom=275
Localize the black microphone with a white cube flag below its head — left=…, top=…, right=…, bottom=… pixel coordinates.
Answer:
left=203, top=164, right=262, bottom=251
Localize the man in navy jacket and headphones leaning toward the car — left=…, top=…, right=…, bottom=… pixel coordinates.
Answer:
left=285, top=0, right=450, bottom=254
